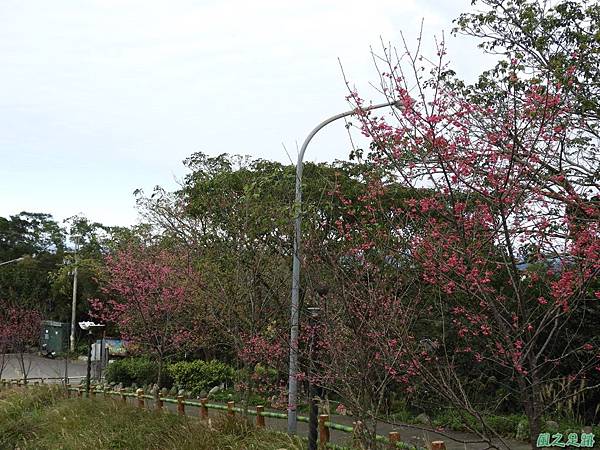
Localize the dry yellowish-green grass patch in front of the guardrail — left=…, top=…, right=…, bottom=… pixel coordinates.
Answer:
left=0, top=387, right=304, bottom=450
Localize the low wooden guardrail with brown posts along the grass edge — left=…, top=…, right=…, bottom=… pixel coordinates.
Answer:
left=2, top=380, right=446, bottom=450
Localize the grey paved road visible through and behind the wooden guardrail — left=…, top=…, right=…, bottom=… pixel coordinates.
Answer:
left=116, top=397, right=531, bottom=450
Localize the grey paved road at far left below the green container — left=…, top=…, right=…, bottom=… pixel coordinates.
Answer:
left=1, top=354, right=86, bottom=380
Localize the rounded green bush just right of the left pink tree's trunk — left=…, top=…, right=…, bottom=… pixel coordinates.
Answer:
left=167, top=360, right=234, bottom=396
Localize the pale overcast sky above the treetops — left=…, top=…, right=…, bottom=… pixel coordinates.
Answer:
left=0, top=0, right=491, bottom=225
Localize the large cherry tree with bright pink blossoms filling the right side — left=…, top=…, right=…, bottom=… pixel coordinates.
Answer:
left=349, top=27, right=600, bottom=448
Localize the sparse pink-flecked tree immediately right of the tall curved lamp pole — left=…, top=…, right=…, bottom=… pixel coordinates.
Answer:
left=300, top=171, right=427, bottom=448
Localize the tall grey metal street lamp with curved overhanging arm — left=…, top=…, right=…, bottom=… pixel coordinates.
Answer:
left=288, top=100, right=398, bottom=434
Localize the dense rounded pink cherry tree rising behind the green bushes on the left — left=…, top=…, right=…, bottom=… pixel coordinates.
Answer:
left=90, top=245, right=202, bottom=385
